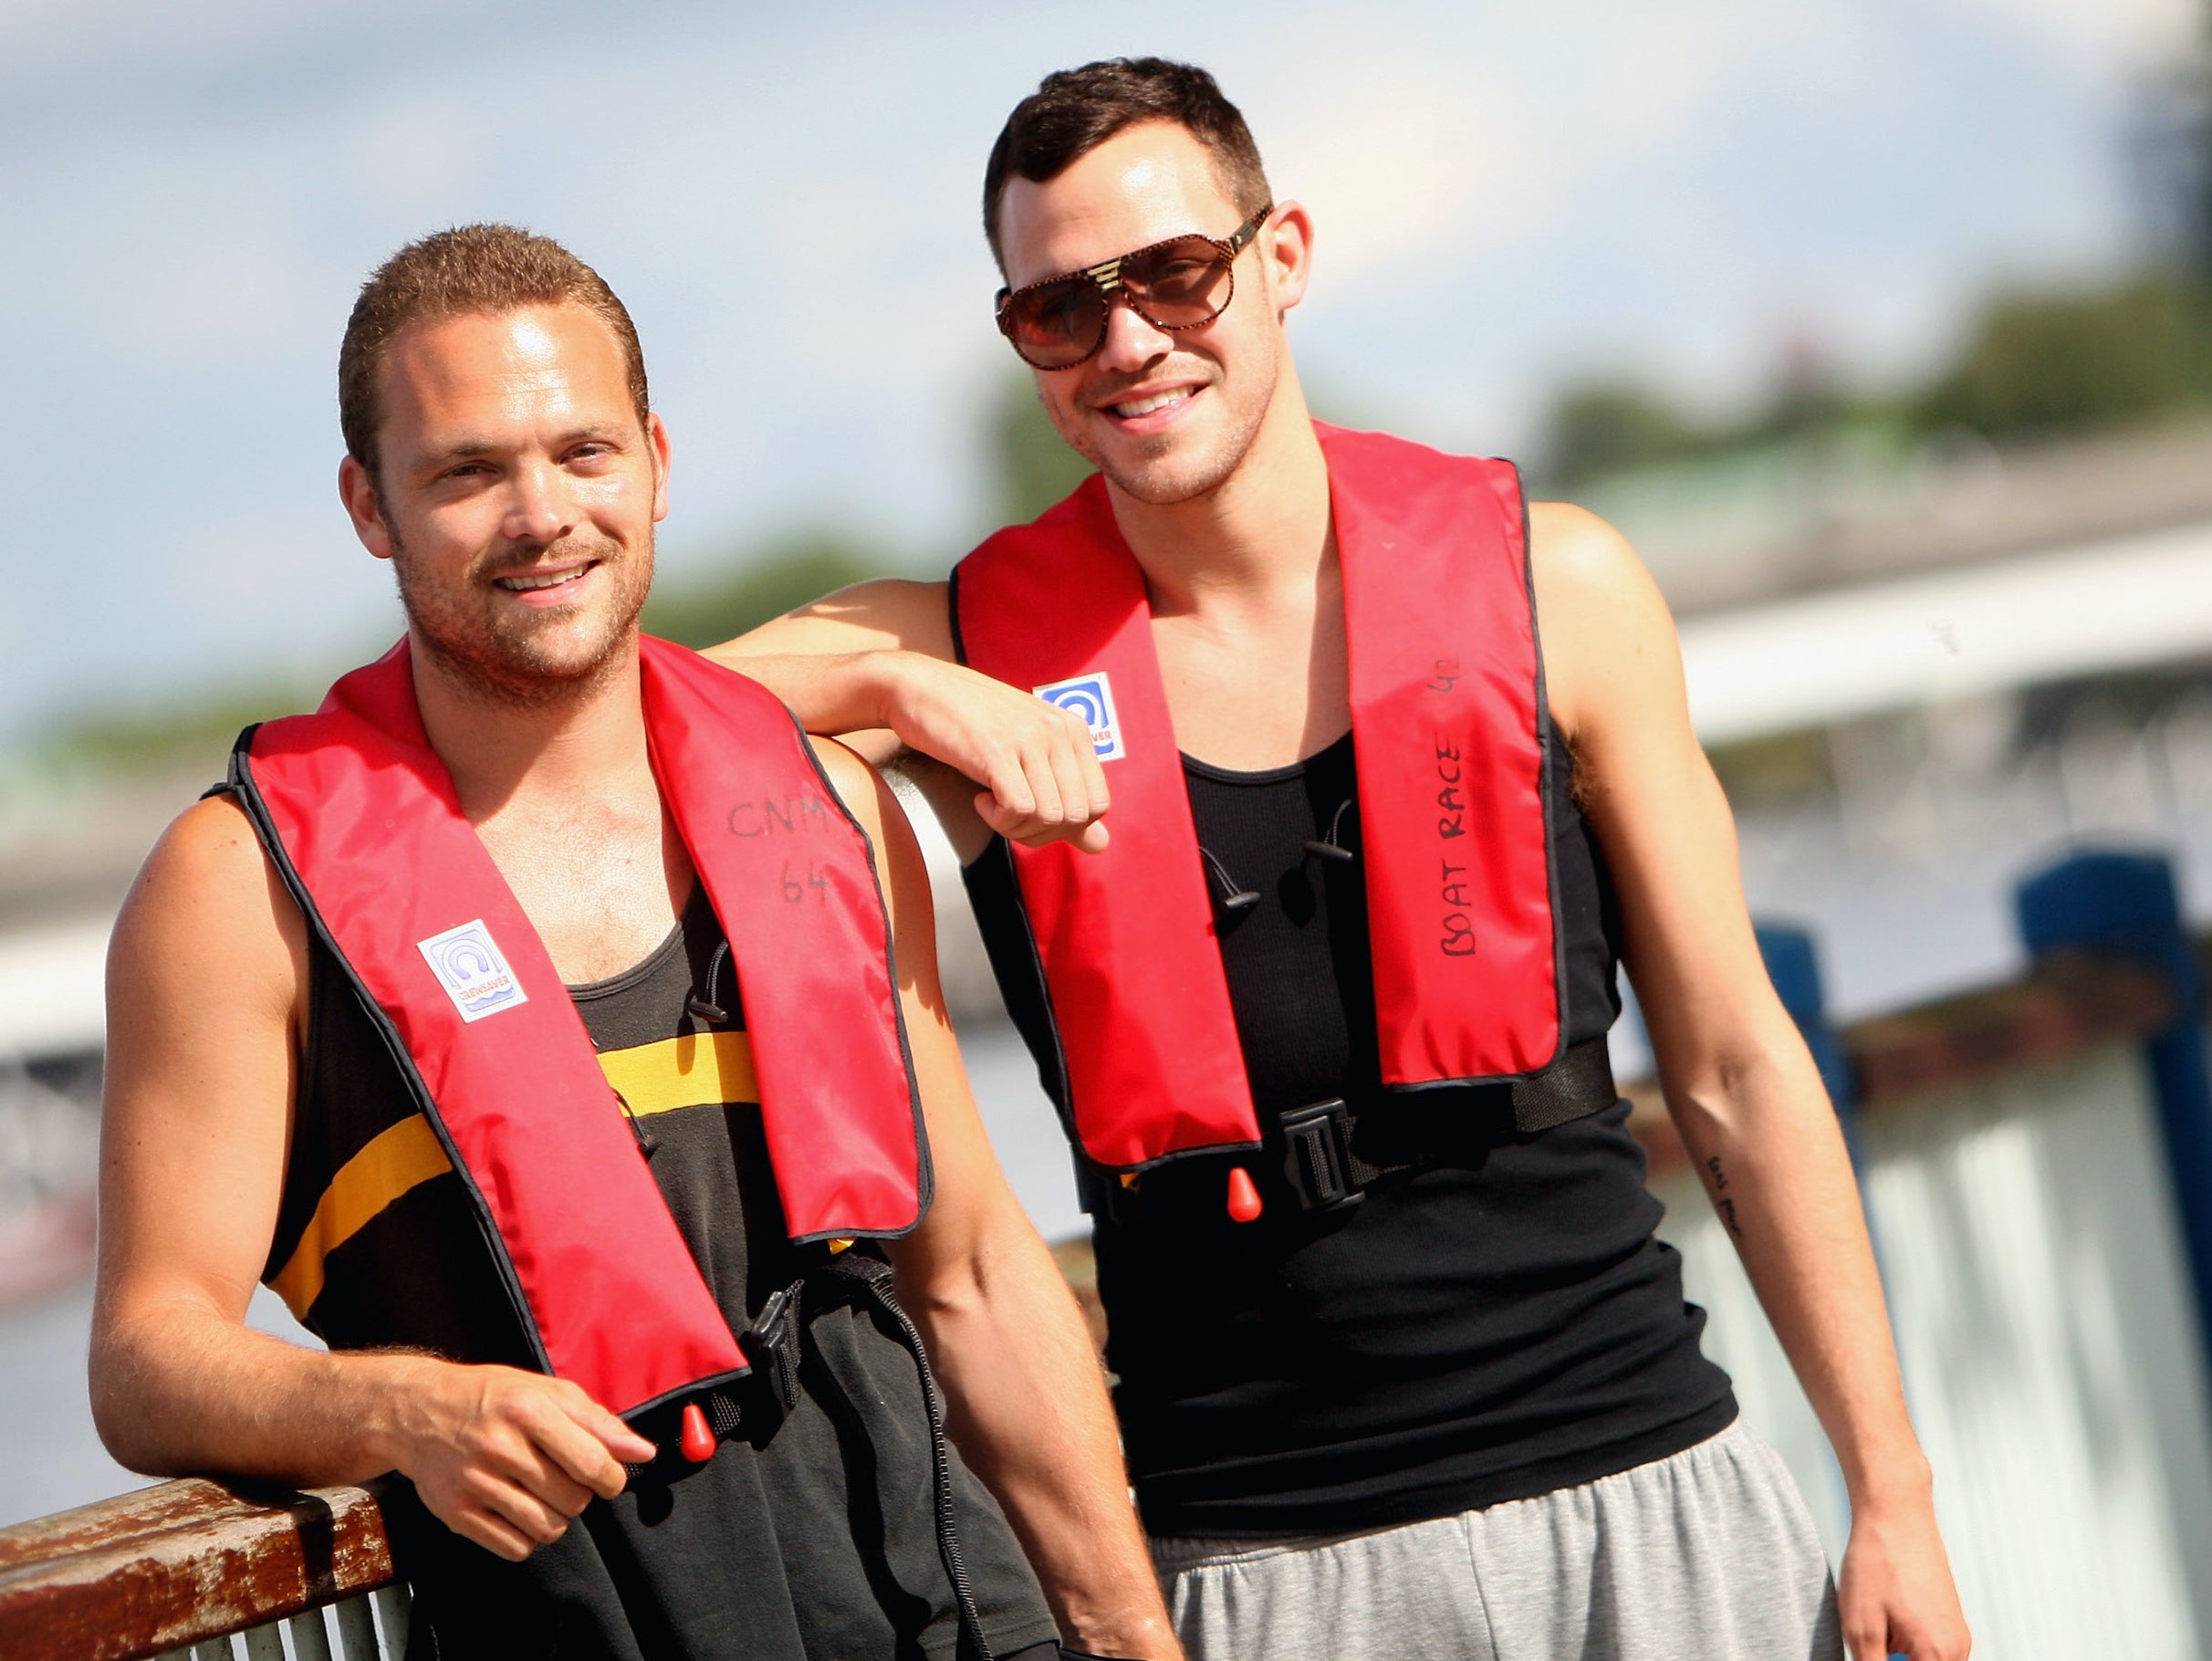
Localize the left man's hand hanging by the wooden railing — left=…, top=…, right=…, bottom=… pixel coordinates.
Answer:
left=391, top=1356, right=652, bottom=1562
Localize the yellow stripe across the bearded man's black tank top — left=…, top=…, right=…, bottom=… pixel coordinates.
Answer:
left=270, top=1033, right=761, bottom=1318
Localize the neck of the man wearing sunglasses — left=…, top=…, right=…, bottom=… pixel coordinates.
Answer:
left=1108, top=362, right=1336, bottom=617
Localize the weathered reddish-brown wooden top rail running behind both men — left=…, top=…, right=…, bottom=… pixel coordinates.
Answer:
left=0, top=928, right=2176, bottom=1661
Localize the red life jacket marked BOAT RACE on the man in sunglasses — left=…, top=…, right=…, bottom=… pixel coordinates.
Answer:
left=954, top=423, right=1566, bottom=1172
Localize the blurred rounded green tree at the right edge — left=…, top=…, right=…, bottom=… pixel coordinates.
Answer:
left=1918, top=272, right=2212, bottom=438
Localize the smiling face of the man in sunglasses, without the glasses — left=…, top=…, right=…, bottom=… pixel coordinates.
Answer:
left=997, top=121, right=1305, bottom=505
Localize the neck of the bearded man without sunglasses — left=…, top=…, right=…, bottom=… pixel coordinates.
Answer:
left=412, top=631, right=652, bottom=825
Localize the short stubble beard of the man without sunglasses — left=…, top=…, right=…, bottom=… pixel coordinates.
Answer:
left=391, top=538, right=652, bottom=710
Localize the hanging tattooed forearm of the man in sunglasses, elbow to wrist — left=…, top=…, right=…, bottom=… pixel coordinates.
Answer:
left=1670, top=1041, right=1929, bottom=1509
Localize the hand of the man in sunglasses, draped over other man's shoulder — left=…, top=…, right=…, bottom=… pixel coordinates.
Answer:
left=878, top=653, right=1111, bottom=853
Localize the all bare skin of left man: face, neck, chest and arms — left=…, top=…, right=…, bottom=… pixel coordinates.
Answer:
left=90, top=291, right=1181, bottom=1661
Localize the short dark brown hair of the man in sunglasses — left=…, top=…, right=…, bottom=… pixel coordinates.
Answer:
left=982, top=57, right=1272, bottom=270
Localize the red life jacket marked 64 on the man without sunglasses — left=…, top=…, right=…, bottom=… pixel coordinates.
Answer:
left=233, top=637, right=929, bottom=1414
